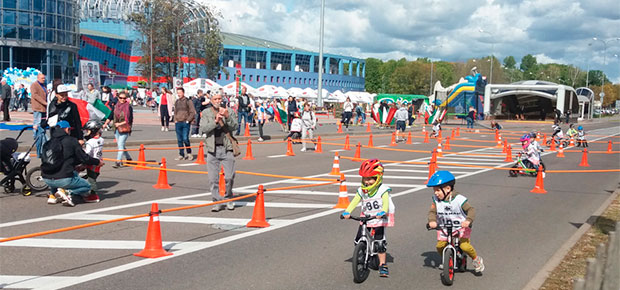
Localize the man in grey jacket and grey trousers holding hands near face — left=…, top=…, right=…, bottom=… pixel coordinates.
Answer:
left=200, top=93, right=238, bottom=212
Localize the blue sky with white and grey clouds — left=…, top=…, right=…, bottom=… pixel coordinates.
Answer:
left=206, top=0, right=620, bottom=83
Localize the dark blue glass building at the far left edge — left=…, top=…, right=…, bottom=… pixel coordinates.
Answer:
left=0, top=0, right=79, bottom=82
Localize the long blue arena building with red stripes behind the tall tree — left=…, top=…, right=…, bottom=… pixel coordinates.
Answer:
left=78, top=0, right=366, bottom=92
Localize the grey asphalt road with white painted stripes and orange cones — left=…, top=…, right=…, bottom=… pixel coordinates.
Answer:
left=0, top=112, right=620, bottom=289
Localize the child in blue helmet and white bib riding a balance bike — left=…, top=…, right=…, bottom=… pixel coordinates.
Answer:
left=426, top=171, right=484, bottom=273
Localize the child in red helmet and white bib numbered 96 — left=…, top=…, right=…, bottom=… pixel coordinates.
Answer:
left=342, top=159, right=394, bottom=277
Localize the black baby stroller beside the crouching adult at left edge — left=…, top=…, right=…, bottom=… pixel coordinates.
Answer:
left=0, top=126, right=47, bottom=196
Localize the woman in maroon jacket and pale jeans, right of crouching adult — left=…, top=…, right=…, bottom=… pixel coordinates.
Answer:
left=112, top=91, right=133, bottom=168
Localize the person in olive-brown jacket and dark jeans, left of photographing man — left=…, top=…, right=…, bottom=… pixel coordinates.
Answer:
left=174, top=88, right=196, bottom=160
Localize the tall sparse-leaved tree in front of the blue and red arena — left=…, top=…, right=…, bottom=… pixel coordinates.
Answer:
left=130, top=0, right=222, bottom=85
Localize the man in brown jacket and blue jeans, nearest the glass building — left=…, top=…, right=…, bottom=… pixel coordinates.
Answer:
left=30, top=73, right=47, bottom=158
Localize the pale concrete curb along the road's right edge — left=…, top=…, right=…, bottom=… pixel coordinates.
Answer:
left=523, top=188, right=620, bottom=290
